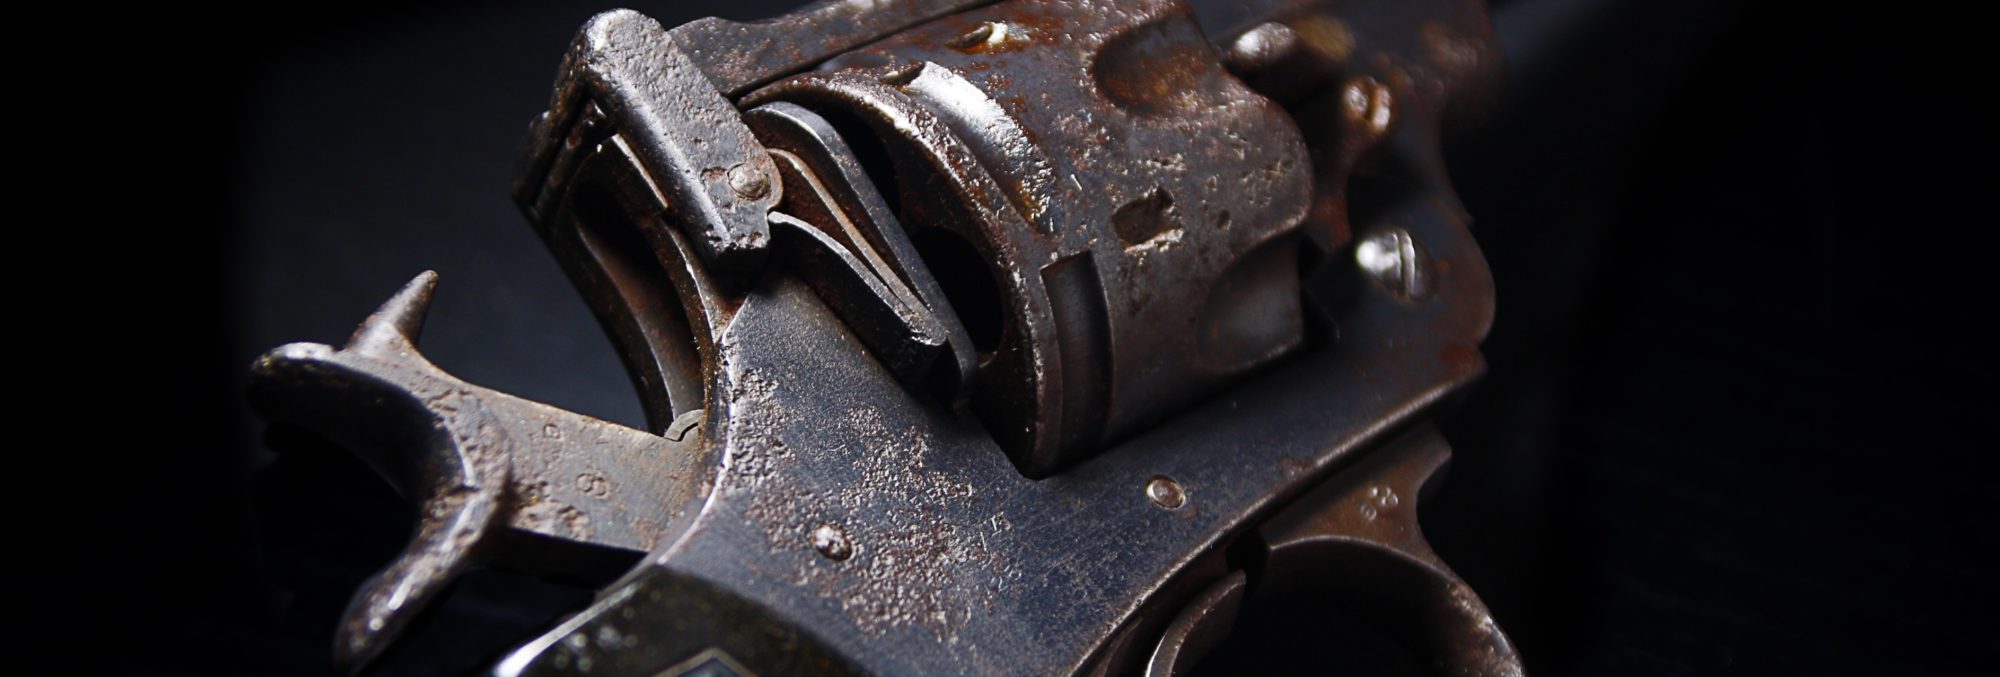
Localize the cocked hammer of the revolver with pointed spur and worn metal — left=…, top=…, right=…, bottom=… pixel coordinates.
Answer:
left=250, top=272, right=710, bottom=669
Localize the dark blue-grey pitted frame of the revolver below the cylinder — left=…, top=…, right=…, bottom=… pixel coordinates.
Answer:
left=500, top=123, right=1490, bottom=673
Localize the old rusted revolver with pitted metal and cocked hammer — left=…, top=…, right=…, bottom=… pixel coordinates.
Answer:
left=252, top=0, right=1520, bottom=675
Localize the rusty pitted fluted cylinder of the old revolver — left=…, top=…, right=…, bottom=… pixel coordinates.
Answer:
left=748, top=0, right=1310, bottom=477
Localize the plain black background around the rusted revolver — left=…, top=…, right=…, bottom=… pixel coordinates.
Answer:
left=43, top=0, right=2000, bottom=675
